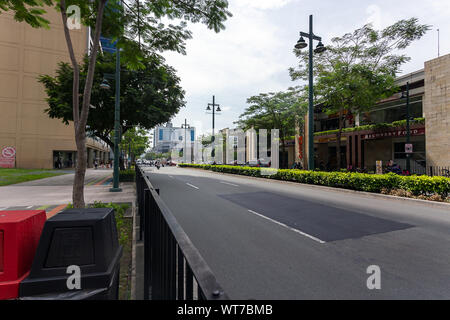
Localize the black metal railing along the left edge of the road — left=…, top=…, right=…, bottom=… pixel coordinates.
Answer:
left=136, top=165, right=228, bottom=300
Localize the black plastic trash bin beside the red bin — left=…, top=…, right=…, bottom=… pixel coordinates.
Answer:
left=19, top=208, right=123, bottom=300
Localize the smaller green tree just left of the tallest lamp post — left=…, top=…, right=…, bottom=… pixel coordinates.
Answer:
left=235, top=87, right=306, bottom=167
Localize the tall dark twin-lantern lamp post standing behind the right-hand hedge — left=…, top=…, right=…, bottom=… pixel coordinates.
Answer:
left=295, top=15, right=326, bottom=170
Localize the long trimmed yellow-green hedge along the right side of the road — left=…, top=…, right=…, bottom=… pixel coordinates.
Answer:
left=178, top=164, right=450, bottom=198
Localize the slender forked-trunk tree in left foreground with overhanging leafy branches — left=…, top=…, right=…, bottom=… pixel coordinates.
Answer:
left=4, top=0, right=231, bottom=208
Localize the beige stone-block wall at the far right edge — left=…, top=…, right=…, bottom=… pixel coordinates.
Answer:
left=423, top=54, right=450, bottom=166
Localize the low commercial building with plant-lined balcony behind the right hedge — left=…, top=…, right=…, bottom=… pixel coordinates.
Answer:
left=305, top=55, right=450, bottom=174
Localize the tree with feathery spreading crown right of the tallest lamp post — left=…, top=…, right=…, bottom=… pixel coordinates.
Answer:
left=289, top=18, right=430, bottom=168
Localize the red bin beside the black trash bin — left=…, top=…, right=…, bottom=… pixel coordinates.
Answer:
left=0, top=210, right=47, bottom=300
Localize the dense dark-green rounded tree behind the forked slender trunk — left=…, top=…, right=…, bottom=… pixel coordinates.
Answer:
left=39, top=53, right=185, bottom=167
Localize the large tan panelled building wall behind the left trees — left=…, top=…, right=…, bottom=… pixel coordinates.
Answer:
left=0, top=8, right=105, bottom=168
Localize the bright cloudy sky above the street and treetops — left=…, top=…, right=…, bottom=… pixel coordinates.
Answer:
left=163, top=0, right=450, bottom=135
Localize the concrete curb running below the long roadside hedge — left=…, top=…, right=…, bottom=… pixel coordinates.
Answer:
left=181, top=168, right=450, bottom=210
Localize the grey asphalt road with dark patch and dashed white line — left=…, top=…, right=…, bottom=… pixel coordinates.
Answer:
left=146, top=167, right=450, bottom=299
